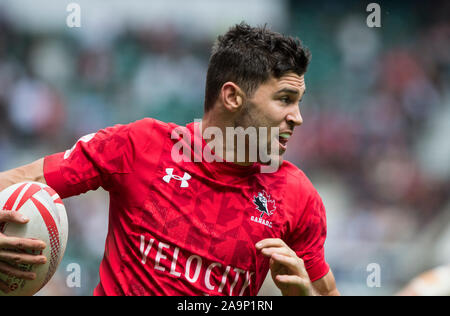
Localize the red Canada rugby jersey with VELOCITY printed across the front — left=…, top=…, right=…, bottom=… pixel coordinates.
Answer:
left=44, top=118, right=329, bottom=296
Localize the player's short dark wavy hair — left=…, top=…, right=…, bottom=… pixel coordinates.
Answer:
left=205, top=22, right=311, bottom=112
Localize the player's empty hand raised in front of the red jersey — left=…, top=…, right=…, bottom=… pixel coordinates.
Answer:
left=256, top=239, right=315, bottom=296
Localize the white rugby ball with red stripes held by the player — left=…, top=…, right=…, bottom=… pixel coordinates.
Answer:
left=0, top=182, right=69, bottom=296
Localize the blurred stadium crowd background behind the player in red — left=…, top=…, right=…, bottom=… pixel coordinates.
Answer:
left=0, top=0, right=450, bottom=295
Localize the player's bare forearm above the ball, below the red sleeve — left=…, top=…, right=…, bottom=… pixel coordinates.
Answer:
left=0, top=158, right=47, bottom=191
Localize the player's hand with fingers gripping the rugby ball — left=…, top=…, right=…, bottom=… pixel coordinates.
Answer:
left=0, top=210, right=47, bottom=293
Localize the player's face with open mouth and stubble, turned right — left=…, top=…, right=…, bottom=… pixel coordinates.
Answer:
left=236, top=72, right=306, bottom=164
